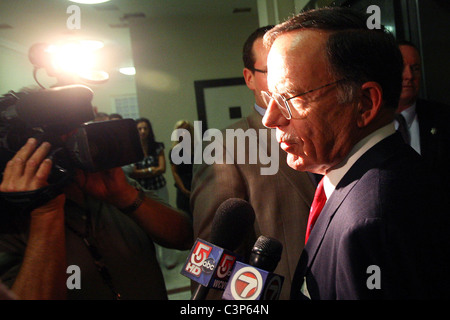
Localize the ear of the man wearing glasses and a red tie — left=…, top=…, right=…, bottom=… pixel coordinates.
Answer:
left=357, top=81, right=383, bottom=128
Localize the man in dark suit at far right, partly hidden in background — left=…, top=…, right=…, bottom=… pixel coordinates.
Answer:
left=397, top=41, right=450, bottom=189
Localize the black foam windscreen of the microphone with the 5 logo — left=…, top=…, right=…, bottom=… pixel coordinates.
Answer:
left=210, top=198, right=255, bottom=251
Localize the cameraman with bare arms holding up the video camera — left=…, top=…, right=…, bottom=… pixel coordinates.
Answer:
left=0, top=138, right=193, bottom=299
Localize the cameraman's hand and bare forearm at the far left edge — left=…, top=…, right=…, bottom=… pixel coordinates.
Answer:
left=0, top=139, right=67, bottom=299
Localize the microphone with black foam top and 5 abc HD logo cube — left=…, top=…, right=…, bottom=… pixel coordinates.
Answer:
left=181, top=198, right=255, bottom=300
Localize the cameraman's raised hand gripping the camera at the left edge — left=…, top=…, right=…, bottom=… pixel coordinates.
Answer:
left=0, top=138, right=52, bottom=192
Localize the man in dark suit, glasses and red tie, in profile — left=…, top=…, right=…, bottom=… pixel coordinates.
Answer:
left=263, top=8, right=448, bottom=299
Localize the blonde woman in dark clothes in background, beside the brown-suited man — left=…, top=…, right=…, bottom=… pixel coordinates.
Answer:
left=170, top=120, right=194, bottom=217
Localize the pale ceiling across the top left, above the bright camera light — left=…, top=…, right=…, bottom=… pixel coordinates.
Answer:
left=0, top=0, right=257, bottom=74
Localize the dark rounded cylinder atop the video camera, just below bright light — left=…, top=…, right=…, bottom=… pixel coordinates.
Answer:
left=1, top=85, right=94, bottom=132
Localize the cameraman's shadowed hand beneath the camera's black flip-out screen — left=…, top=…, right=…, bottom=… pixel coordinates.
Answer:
left=75, top=167, right=138, bottom=208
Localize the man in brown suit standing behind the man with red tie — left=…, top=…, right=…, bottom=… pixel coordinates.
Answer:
left=191, top=26, right=315, bottom=299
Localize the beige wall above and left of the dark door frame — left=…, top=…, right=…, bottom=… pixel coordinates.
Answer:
left=130, top=15, right=258, bottom=204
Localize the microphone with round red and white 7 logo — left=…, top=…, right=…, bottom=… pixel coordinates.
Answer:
left=222, top=236, right=284, bottom=300
